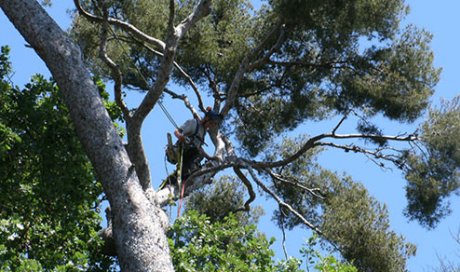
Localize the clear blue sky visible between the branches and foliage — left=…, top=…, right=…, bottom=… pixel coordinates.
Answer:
left=0, top=0, right=460, bottom=272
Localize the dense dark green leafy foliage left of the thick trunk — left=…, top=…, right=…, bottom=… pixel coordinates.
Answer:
left=0, top=50, right=112, bottom=271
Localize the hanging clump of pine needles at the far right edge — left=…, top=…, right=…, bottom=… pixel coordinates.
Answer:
left=405, top=97, right=460, bottom=227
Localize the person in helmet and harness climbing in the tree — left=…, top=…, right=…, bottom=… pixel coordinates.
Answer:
left=159, top=107, right=221, bottom=190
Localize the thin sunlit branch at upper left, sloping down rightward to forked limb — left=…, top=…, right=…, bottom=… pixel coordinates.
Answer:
left=74, top=0, right=166, bottom=50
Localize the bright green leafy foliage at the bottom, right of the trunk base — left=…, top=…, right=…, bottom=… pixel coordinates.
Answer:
left=169, top=211, right=301, bottom=272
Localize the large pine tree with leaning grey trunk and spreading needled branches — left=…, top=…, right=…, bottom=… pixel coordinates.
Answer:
left=0, top=0, right=459, bottom=271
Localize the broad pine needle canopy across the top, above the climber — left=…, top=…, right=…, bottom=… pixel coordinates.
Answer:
left=72, top=0, right=439, bottom=155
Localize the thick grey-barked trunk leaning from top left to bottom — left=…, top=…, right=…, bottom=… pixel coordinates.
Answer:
left=0, top=0, right=173, bottom=272
